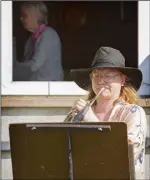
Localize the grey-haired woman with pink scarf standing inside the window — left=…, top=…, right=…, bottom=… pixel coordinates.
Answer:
left=15, top=1, right=64, bottom=81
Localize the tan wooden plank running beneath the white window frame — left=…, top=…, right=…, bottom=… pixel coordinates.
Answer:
left=2, top=95, right=150, bottom=107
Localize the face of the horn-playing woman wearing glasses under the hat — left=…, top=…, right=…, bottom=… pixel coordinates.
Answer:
left=90, top=68, right=126, bottom=99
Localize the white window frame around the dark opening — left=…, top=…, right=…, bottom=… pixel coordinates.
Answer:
left=1, top=1, right=150, bottom=95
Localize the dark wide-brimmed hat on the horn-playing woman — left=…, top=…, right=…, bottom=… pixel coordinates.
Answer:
left=70, top=47, right=142, bottom=90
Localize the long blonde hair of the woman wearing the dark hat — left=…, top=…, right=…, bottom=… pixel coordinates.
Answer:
left=87, top=84, right=140, bottom=104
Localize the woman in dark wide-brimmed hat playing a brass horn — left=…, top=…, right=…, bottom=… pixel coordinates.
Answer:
left=71, top=47, right=146, bottom=179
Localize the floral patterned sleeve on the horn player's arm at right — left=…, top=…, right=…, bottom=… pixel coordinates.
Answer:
left=126, top=105, right=147, bottom=179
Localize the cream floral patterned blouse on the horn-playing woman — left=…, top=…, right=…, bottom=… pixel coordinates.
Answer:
left=108, top=101, right=147, bottom=179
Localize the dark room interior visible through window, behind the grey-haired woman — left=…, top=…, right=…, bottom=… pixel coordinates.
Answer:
left=13, top=1, right=138, bottom=79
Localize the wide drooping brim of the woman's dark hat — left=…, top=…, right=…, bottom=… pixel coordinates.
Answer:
left=70, top=67, right=142, bottom=91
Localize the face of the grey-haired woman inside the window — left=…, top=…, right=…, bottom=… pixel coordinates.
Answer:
left=20, top=8, right=38, bottom=32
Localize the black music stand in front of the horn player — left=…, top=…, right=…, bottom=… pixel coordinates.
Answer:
left=9, top=123, right=130, bottom=180
